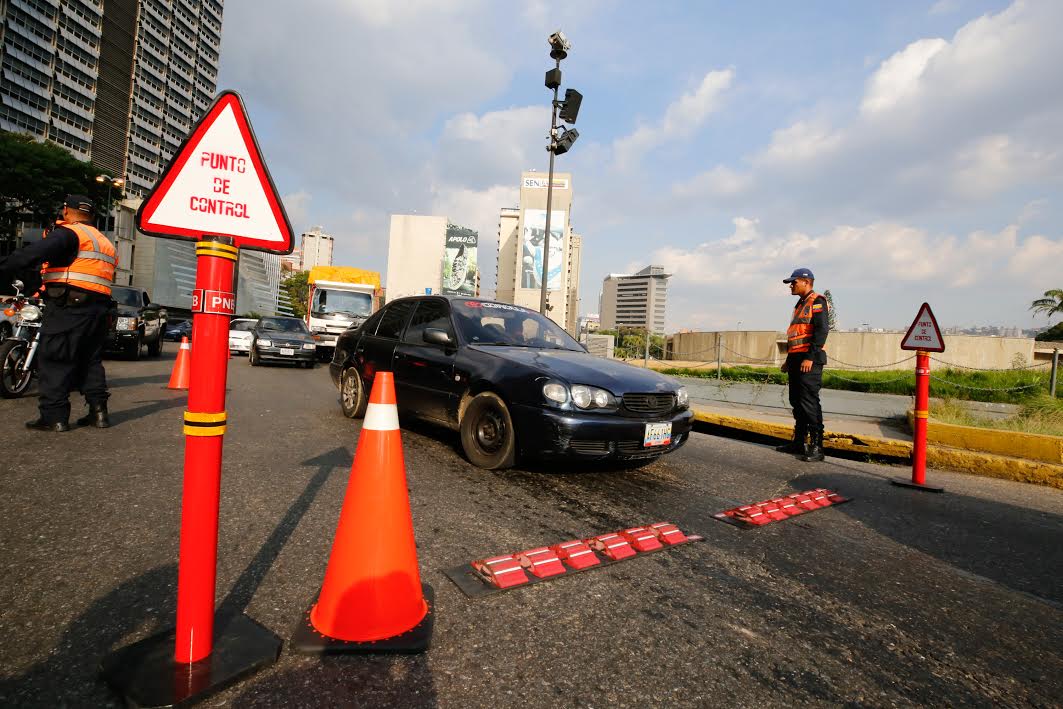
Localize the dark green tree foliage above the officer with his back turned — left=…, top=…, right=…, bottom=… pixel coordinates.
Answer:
left=0, top=131, right=121, bottom=254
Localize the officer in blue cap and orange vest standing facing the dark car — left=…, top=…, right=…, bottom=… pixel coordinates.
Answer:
left=775, top=268, right=830, bottom=462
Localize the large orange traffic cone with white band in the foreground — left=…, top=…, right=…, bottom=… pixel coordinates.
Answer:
left=292, top=372, right=433, bottom=653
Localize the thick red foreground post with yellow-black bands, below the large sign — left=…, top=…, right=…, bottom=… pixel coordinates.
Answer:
left=174, top=237, right=238, bottom=663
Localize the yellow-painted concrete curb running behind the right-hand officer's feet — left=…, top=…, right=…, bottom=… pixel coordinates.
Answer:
left=694, top=408, right=1063, bottom=490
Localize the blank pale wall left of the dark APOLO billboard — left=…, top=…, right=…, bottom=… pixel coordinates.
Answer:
left=385, top=214, right=446, bottom=303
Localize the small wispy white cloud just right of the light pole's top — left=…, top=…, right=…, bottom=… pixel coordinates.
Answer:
left=613, top=69, right=735, bottom=168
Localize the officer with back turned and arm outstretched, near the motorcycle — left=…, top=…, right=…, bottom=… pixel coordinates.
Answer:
left=0, top=195, right=118, bottom=433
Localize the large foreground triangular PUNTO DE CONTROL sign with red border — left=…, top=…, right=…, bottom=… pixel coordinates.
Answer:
left=136, top=91, right=294, bottom=254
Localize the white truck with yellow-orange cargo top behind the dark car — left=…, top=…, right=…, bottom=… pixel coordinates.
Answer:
left=306, top=266, right=381, bottom=360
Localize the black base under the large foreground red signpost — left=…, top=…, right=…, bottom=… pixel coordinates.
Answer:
left=100, top=614, right=282, bottom=707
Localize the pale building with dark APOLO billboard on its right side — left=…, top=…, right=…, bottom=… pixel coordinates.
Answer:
left=385, top=215, right=479, bottom=302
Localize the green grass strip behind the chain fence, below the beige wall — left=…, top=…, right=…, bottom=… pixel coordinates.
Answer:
left=661, top=366, right=1048, bottom=404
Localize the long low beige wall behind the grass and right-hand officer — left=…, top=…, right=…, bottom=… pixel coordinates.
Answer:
left=667, top=331, right=1040, bottom=369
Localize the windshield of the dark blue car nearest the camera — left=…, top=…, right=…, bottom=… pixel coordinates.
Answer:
left=452, top=301, right=583, bottom=352
